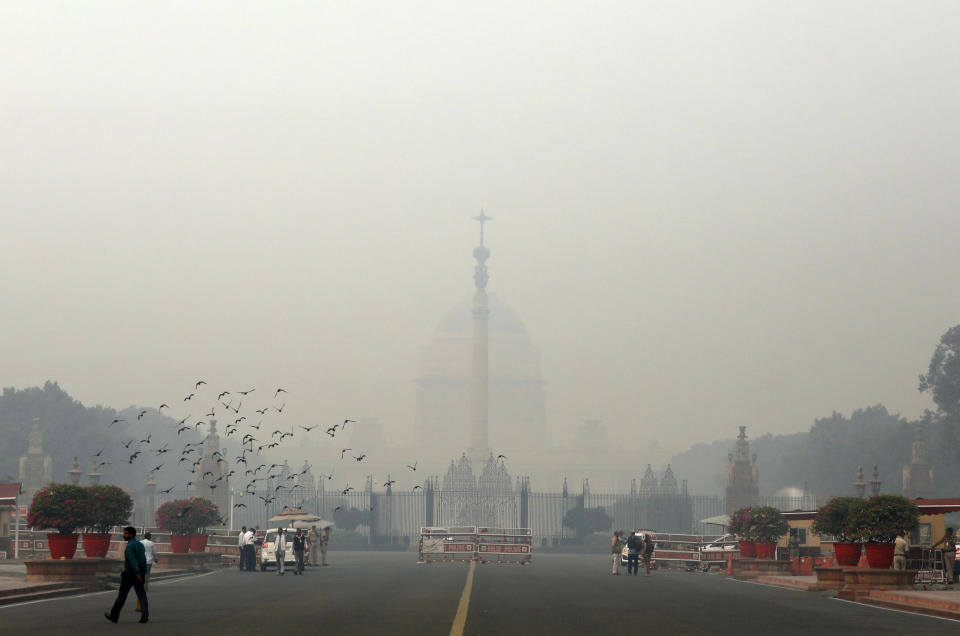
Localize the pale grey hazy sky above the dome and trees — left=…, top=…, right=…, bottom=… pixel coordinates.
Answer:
left=0, top=0, right=960, bottom=458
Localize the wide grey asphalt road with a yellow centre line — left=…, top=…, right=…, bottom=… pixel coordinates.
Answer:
left=0, top=552, right=960, bottom=636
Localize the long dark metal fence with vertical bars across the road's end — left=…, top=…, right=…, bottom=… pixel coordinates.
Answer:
left=156, top=482, right=814, bottom=543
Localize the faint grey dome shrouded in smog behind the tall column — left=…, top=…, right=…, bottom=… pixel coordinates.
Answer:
left=414, top=294, right=549, bottom=454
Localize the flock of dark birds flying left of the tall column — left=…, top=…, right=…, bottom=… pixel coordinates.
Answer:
left=93, top=380, right=446, bottom=511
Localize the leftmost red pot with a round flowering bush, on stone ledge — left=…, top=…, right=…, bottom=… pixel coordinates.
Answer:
left=27, top=484, right=89, bottom=559
